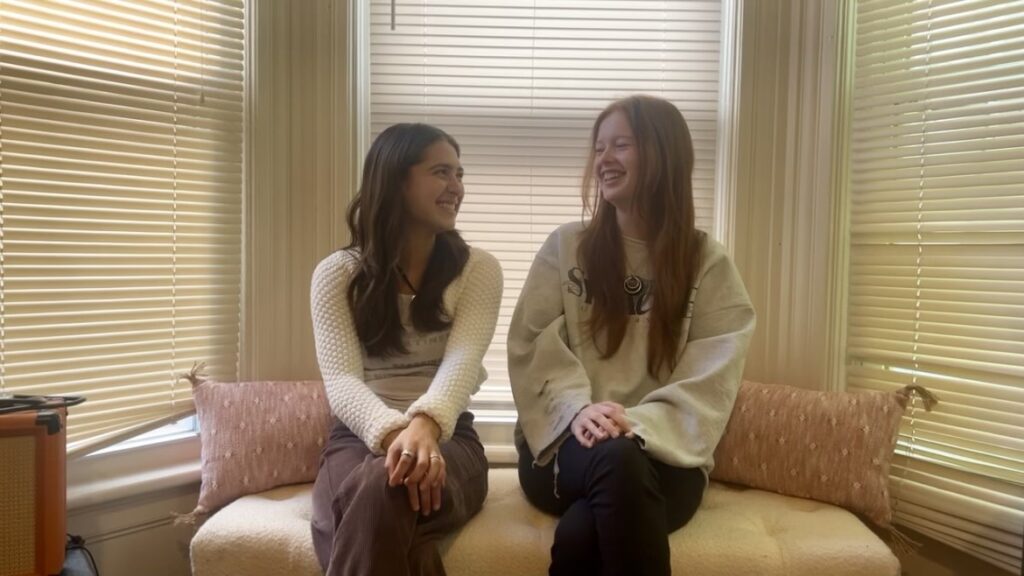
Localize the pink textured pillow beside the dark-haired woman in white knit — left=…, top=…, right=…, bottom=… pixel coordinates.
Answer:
left=193, top=381, right=331, bottom=513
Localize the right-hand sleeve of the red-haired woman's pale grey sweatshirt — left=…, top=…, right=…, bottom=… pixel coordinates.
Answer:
left=626, top=252, right=756, bottom=471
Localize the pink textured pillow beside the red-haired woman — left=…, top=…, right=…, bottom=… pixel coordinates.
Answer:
left=711, top=382, right=909, bottom=528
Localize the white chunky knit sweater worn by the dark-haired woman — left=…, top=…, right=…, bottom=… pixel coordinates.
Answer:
left=310, top=248, right=503, bottom=454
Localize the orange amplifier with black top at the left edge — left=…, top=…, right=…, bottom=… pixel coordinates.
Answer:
left=0, top=397, right=80, bottom=576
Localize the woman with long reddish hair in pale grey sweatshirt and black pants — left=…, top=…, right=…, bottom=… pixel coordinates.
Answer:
left=508, top=96, right=755, bottom=575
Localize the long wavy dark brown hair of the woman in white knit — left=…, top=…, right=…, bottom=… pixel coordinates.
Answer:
left=346, top=124, right=469, bottom=356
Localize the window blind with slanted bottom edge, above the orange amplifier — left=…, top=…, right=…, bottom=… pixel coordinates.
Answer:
left=0, top=0, right=244, bottom=452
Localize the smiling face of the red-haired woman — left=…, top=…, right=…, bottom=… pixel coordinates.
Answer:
left=593, top=110, right=639, bottom=211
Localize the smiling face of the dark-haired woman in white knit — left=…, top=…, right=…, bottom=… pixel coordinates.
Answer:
left=402, top=140, right=466, bottom=234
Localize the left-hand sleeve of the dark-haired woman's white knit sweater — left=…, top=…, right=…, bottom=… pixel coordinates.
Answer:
left=310, top=251, right=409, bottom=455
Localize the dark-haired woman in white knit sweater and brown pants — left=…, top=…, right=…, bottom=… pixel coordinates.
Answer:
left=311, top=124, right=502, bottom=576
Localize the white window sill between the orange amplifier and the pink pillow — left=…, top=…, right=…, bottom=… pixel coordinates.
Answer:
left=68, top=433, right=201, bottom=510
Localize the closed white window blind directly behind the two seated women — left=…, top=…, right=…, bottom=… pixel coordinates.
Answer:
left=370, top=0, right=722, bottom=412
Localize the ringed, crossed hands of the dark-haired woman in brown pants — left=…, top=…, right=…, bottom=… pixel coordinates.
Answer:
left=384, top=414, right=447, bottom=516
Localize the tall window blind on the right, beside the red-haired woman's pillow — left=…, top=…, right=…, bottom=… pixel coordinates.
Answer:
left=847, top=0, right=1024, bottom=574
